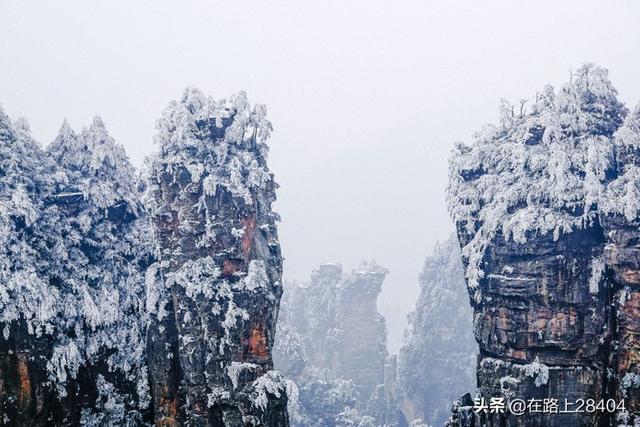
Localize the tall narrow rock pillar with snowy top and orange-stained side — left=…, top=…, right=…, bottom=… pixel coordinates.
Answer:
left=147, top=89, right=287, bottom=426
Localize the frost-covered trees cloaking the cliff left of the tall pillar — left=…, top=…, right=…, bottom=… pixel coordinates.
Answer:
left=0, top=111, right=149, bottom=425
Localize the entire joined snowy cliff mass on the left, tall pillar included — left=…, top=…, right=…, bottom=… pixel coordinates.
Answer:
left=0, top=89, right=288, bottom=426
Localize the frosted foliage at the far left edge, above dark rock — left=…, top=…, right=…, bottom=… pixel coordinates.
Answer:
left=0, top=108, right=55, bottom=340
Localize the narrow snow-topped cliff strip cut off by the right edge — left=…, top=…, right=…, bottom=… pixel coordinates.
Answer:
left=600, top=106, right=640, bottom=424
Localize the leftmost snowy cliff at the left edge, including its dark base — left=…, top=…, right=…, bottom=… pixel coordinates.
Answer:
left=0, top=108, right=66, bottom=425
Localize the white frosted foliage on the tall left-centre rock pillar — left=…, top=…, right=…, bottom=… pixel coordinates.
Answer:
left=147, top=87, right=277, bottom=353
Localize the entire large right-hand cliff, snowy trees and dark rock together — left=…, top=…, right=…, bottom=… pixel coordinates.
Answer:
left=449, top=65, right=640, bottom=426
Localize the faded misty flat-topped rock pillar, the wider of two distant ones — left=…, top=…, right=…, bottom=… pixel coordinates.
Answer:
left=274, top=263, right=398, bottom=426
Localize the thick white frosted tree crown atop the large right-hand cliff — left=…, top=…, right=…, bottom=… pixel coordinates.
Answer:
left=448, top=64, right=627, bottom=294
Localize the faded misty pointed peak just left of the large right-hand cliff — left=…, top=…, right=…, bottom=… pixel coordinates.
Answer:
left=398, top=236, right=478, bottom=426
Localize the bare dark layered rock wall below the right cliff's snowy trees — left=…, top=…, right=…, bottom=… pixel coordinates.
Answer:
left=448, top=228, right=611, bottom=425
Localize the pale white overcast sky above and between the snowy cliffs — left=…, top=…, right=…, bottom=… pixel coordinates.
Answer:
left=0, top=0, right=640, bottom=350
